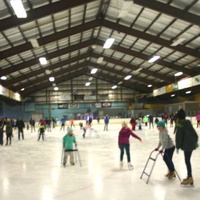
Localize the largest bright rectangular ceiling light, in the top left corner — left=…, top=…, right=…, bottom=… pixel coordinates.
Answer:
left=10, top=0, right=27, bottom=18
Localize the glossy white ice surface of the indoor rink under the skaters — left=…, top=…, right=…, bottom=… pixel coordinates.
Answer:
left=0, top=120, right=200, bottom=200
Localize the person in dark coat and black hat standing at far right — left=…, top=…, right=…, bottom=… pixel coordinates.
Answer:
left=175, top=109, right=198, bottom=185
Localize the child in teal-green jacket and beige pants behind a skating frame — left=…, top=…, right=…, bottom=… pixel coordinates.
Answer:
left=63, top=127, right=77, bottom=167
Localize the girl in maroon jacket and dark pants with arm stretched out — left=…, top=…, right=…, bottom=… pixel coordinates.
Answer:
left=118, top=122, right=142, bottom=170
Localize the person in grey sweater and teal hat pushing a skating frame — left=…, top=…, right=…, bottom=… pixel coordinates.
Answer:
left=155, top=120, right=176, bottom=179
